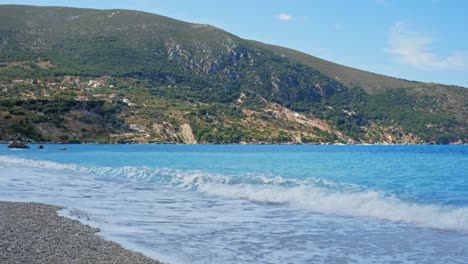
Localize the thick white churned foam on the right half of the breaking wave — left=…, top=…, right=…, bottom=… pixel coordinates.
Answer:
left=199, top=184, right=468, bottom=232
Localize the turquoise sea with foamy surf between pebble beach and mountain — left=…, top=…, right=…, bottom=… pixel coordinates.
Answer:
left=0, top=144, right=468, bottom=264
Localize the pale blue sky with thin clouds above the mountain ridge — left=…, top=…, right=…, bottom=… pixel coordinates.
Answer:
left=0, top=0, right=468, bottom=87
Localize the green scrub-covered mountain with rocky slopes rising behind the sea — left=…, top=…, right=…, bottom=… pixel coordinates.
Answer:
left=0, top=5, right=468, bottom=144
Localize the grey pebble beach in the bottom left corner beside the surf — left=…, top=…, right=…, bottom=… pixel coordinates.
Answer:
left=0, top=201, right=161, bottom=264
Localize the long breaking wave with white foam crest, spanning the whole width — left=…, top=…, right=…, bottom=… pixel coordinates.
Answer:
left=0, top=156, right=468, bottom=232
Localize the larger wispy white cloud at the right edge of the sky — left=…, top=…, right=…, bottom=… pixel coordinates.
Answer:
left=386, top=22, right=468, bottom=70
